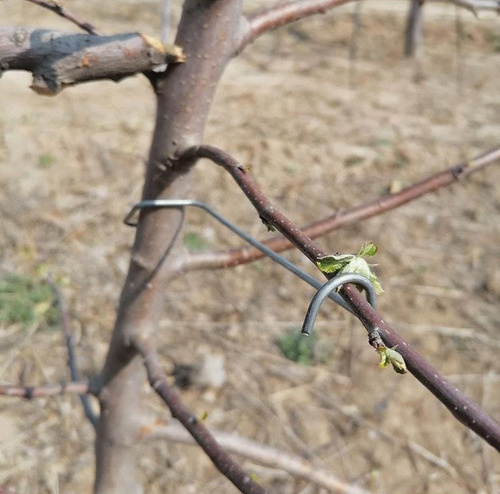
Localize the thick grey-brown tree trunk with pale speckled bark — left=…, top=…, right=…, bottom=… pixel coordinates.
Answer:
left=95, top=0, right=241, bottom=494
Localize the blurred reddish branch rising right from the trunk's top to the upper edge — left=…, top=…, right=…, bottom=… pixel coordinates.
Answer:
left=237, top=0, right=355, bottom=52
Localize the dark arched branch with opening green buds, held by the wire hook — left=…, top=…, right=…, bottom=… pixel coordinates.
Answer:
left=185, top=145, right=500, bottom=451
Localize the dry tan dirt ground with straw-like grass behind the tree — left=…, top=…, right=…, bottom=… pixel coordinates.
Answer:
left=0, top=0, right=500, bottom=494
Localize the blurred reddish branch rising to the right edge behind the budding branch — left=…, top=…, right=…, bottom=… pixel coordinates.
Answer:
left=179, top=146, right=500, bottom=271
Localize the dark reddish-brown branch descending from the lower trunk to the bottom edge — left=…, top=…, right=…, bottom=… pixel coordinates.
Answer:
left=135, top=340, right=266, bottom=494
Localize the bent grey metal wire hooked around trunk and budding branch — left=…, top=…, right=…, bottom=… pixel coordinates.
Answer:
left=123, top=199, right=376, bottom=318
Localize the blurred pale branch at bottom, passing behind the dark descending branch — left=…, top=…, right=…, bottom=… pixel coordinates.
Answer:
left=143, top=424, right=368, bottom=494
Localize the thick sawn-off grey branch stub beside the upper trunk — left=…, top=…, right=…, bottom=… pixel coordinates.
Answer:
left=0, top=26, right=184, bottom=95
